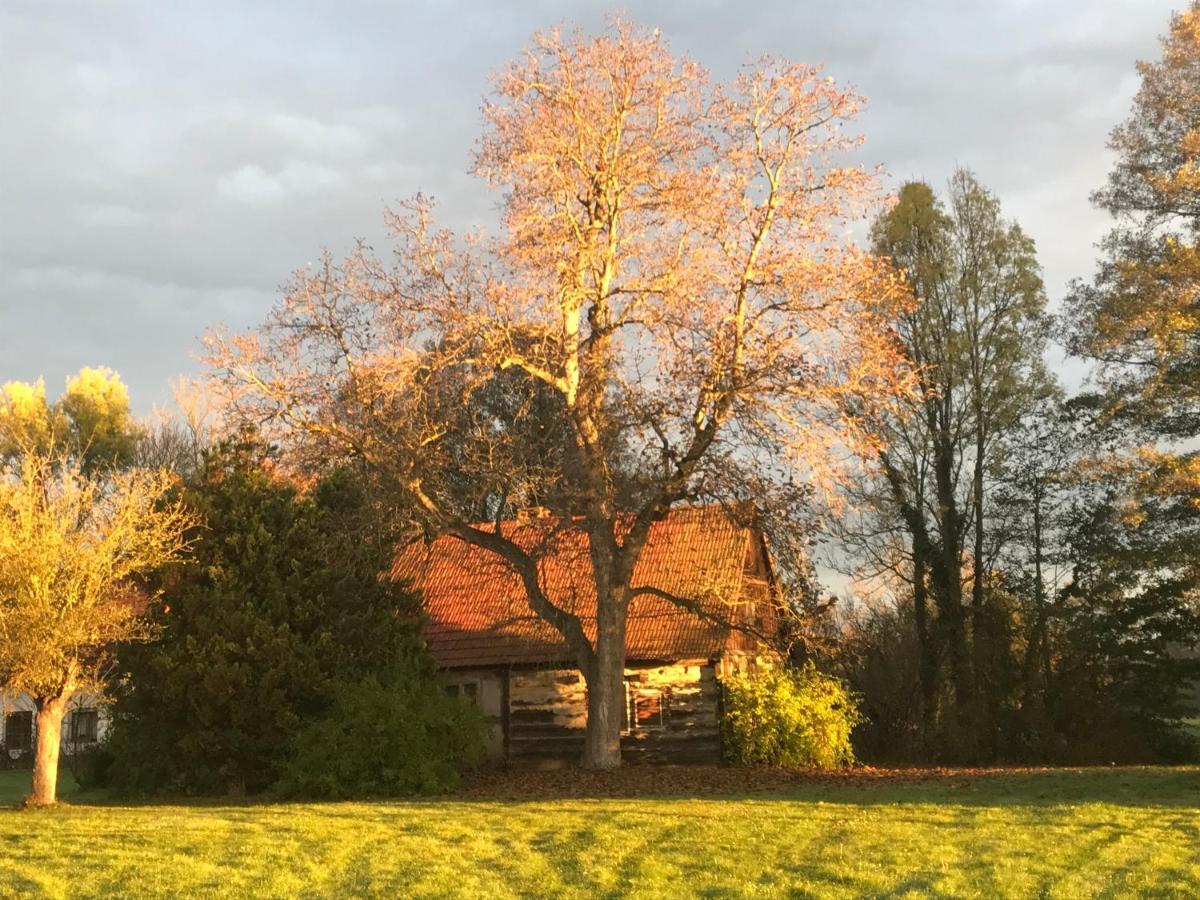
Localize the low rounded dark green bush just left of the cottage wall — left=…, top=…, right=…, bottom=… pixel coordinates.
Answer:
left=276, top=671, right=487, bottom=799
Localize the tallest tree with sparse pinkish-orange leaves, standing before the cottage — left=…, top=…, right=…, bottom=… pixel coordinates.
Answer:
left=210, top=23, right=908, bottom=768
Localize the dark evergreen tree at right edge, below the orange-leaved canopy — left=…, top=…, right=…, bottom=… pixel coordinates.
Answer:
left=1050, top=415, right=1200, bottom=762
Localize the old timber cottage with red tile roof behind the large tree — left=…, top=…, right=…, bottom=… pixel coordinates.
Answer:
left=394, top=506, right=778, bottom=764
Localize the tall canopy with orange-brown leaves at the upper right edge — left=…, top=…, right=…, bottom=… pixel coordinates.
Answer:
left=1068, top=4, right=1200, bottom=465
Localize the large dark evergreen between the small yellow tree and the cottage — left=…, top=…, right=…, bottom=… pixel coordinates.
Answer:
left=112, top=440, right=437, bottom=793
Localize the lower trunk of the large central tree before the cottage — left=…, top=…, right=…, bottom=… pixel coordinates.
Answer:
left=583, top=592, right=628, bottom=769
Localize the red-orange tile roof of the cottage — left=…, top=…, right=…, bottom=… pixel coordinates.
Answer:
left=392, top=506, right=767, bottom=667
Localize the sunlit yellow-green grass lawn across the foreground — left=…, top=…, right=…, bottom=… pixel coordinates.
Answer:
left=0, top=768, right=1200, bottom=900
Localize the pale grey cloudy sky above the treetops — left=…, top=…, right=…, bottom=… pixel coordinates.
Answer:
left=0, top=0, right=1182, bottom=410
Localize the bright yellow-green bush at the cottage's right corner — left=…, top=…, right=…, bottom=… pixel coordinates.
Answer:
left=724, top=662, right=862, bottom=769
